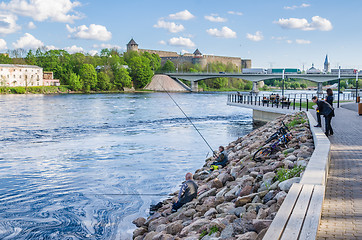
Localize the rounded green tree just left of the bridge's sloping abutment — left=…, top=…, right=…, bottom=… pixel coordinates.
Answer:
left=128, top=57, right=153, bottom=88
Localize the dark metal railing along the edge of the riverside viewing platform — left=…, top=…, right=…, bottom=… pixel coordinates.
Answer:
left=228, top=94, right=312, bottom=111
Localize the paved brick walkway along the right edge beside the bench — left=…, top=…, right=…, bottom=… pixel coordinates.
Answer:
left=311, top=104, right=362, bottom=240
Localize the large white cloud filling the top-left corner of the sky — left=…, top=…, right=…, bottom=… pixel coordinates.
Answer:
left=0, top=0, right=83, bottom=23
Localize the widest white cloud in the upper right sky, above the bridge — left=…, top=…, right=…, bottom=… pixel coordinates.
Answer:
left=274, top=16, right=333, bottom=31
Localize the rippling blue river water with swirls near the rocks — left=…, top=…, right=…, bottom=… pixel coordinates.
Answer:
left=0, top=93, right=253, bottom=239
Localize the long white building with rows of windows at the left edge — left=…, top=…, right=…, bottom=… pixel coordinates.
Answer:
left=0, top=64, right=43, bottom=87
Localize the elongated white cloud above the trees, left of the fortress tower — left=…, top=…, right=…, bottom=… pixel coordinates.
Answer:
left=66, top=24, right=112, bottom=41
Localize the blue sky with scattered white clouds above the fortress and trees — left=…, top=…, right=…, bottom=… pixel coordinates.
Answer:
left=0, top=0, right=362, bottom=69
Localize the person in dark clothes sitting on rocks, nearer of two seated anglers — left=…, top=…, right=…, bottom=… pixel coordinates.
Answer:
left=171, top=172, right=198, bottom=212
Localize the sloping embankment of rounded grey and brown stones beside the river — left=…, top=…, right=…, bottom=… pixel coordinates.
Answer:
left=133, top=113, right=314, bottom=240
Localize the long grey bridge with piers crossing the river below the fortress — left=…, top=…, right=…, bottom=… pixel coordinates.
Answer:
left=164, top=72, right=358, bottom=93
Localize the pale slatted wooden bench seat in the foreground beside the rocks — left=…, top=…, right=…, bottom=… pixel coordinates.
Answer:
left=263, top=183, right=325, bottom=240
